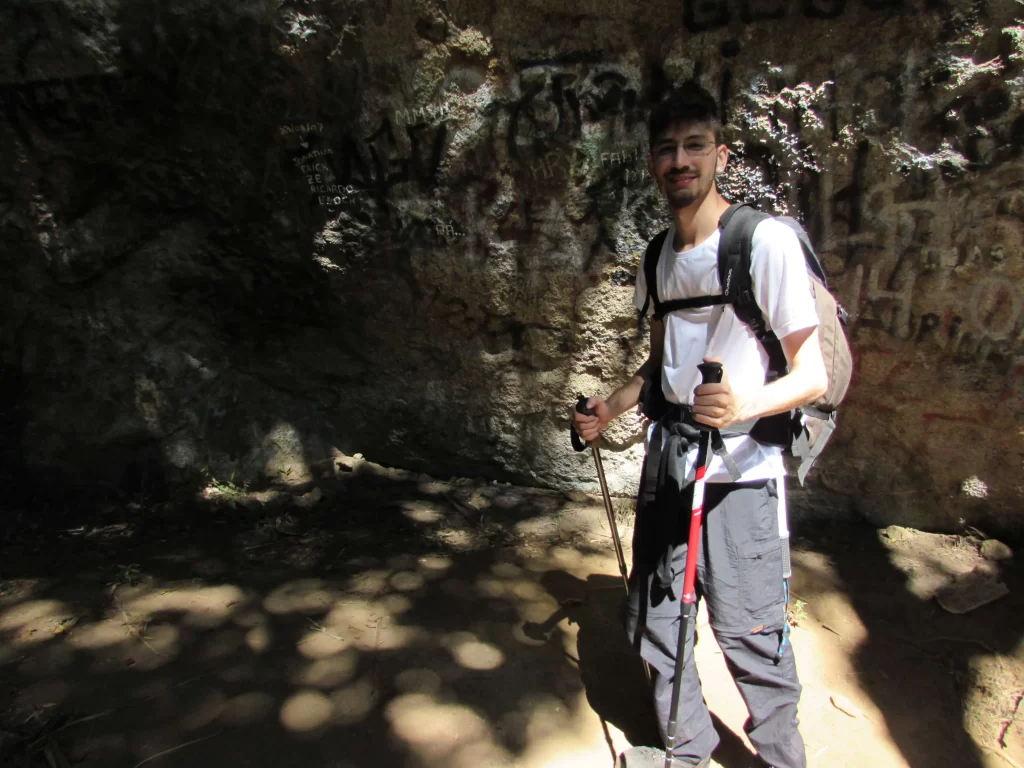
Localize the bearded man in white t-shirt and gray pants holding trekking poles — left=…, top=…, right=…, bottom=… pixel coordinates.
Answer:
left=574, top=86, right=827, bottom=768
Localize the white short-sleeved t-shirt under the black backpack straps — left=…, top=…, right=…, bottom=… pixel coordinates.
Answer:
left=633, top=219, right=818, bottom=482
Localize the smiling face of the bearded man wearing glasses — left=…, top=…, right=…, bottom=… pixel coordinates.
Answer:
left=647, top=123, right=729, bottom=210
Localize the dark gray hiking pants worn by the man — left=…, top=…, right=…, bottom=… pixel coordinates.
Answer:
left=626, top=481, right=807, bottom=768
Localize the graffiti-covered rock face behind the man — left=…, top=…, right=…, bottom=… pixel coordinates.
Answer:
left=6, top=0, right=1024, bottom=530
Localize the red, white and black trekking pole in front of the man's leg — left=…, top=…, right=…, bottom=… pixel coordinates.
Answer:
left=665, top=362, right=722, bottom=768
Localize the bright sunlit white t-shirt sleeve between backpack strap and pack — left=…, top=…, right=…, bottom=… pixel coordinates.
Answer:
left=749, top=219, right=818, bottom=339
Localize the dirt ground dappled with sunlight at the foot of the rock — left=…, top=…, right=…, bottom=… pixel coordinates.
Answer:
left=0, top=461, right=1024, bottom=768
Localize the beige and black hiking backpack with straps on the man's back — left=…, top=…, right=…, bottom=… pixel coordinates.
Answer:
left=640, top=203, right=853, bottom=485
